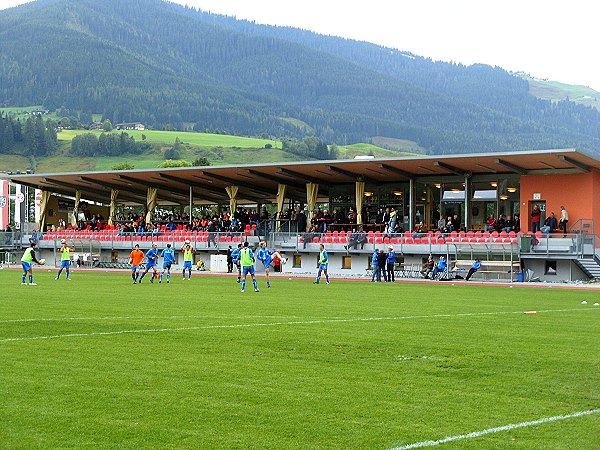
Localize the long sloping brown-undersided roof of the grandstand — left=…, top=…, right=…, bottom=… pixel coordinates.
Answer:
left=4, top=149, right=600, bottom=205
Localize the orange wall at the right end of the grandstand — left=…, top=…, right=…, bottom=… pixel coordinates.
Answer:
left=520, top=169, right=600, bottom=233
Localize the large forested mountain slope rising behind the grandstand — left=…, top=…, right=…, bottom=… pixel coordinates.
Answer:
left=0, top=0, right=600, bottom=153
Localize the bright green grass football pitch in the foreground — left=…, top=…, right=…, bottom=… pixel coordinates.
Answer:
left=0, top=268, right=600, bottom=449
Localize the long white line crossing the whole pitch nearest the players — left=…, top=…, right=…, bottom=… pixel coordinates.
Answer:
left=0, top=308, right=594, bottom=343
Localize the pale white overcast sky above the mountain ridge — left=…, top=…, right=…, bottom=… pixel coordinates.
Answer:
left=0, top=0, right=600, bottom=91
